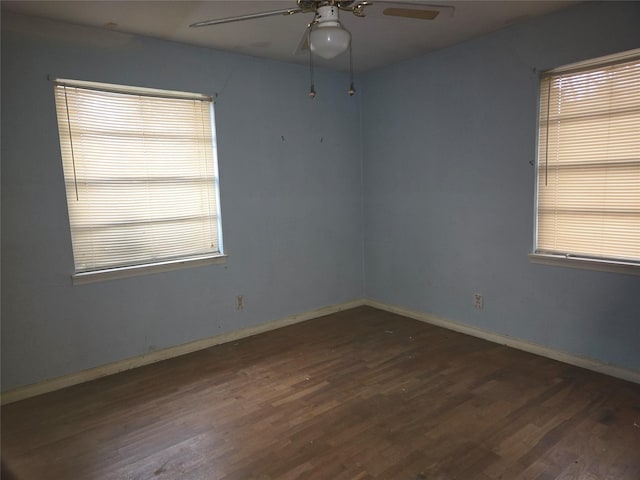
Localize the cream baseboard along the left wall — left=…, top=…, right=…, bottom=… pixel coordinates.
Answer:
left=1, top=300, right=364, bottom=405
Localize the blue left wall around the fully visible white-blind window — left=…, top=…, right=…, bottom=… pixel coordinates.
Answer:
left=2, top=12, right=362, bottom=390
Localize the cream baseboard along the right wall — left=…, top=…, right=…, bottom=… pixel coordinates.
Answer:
left=364, top=299, right=640, bottom=384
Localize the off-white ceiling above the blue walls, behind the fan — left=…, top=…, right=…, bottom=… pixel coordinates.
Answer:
left=2, top=0, right=576, bottom=72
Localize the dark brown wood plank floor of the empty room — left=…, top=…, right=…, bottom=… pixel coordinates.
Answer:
left=2, top=307, right=640, bottom=480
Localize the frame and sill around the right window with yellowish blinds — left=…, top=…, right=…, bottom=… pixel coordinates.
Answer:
left=528, top=49, right=640, bottom=275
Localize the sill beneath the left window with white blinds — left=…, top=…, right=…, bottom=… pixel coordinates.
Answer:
left=71, top=255, right=227, bottom=285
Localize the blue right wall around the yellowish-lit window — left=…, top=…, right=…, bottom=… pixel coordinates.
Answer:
left=361, top=2, right=640, bottom=369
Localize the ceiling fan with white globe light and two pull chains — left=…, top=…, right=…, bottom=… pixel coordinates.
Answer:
left=189, top=0, right=454, bottom=98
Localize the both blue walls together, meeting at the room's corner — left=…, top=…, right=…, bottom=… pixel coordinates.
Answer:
left=2, top=2, right=640, bottom=389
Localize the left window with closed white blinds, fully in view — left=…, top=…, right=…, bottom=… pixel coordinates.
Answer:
left=55, top=80, right=222, bottom=282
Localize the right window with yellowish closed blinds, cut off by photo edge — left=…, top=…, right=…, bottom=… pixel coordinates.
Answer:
left=532, top=49, right=640, bottom=273
